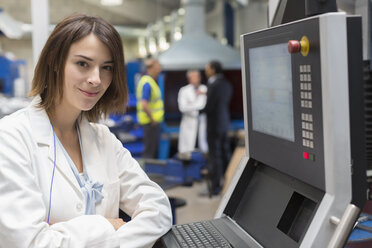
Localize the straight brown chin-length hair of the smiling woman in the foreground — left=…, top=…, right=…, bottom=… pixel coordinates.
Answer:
left=29, top=14, right=128, bottom=121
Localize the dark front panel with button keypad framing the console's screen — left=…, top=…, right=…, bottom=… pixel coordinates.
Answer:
left=242, top=19, right=325, bottom=190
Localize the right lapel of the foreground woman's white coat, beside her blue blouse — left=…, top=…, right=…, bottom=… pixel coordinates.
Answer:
left=79, top=117, right=106, bottom=183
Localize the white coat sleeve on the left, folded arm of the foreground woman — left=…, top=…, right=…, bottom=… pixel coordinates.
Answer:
left=0, top=122, right=118, bottom=248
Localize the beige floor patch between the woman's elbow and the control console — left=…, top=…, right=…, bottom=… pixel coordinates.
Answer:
left=165, top=180, right=222, bottom=224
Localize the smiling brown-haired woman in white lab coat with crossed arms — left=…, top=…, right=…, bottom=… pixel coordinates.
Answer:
left=0, top=14, right=172, bottom=248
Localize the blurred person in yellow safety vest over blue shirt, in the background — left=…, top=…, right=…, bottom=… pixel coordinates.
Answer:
left=136, top=58, right=164, bottom=158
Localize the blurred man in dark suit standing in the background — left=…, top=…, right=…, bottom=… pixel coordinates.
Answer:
left=203, top=61, right=233, bottom=196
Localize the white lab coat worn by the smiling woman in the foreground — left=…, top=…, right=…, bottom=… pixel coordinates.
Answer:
left=0, top=97, right=172, bottom=248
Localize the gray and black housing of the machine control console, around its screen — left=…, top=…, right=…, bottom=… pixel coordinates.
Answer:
left=216, top=13, right=366, bottom=247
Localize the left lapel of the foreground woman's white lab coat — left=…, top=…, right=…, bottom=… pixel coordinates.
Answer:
left=29, top=96, right=83, bottom=197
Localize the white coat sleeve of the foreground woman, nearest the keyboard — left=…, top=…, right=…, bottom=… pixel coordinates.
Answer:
left=112, top=135, right=172, bottom=248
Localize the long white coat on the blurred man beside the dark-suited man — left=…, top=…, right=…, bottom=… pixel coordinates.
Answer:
left=178, top=84, right=208, bottom=153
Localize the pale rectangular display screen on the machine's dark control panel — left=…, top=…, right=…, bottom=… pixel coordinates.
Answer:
left=249, top=43, right=295, bottom=141
